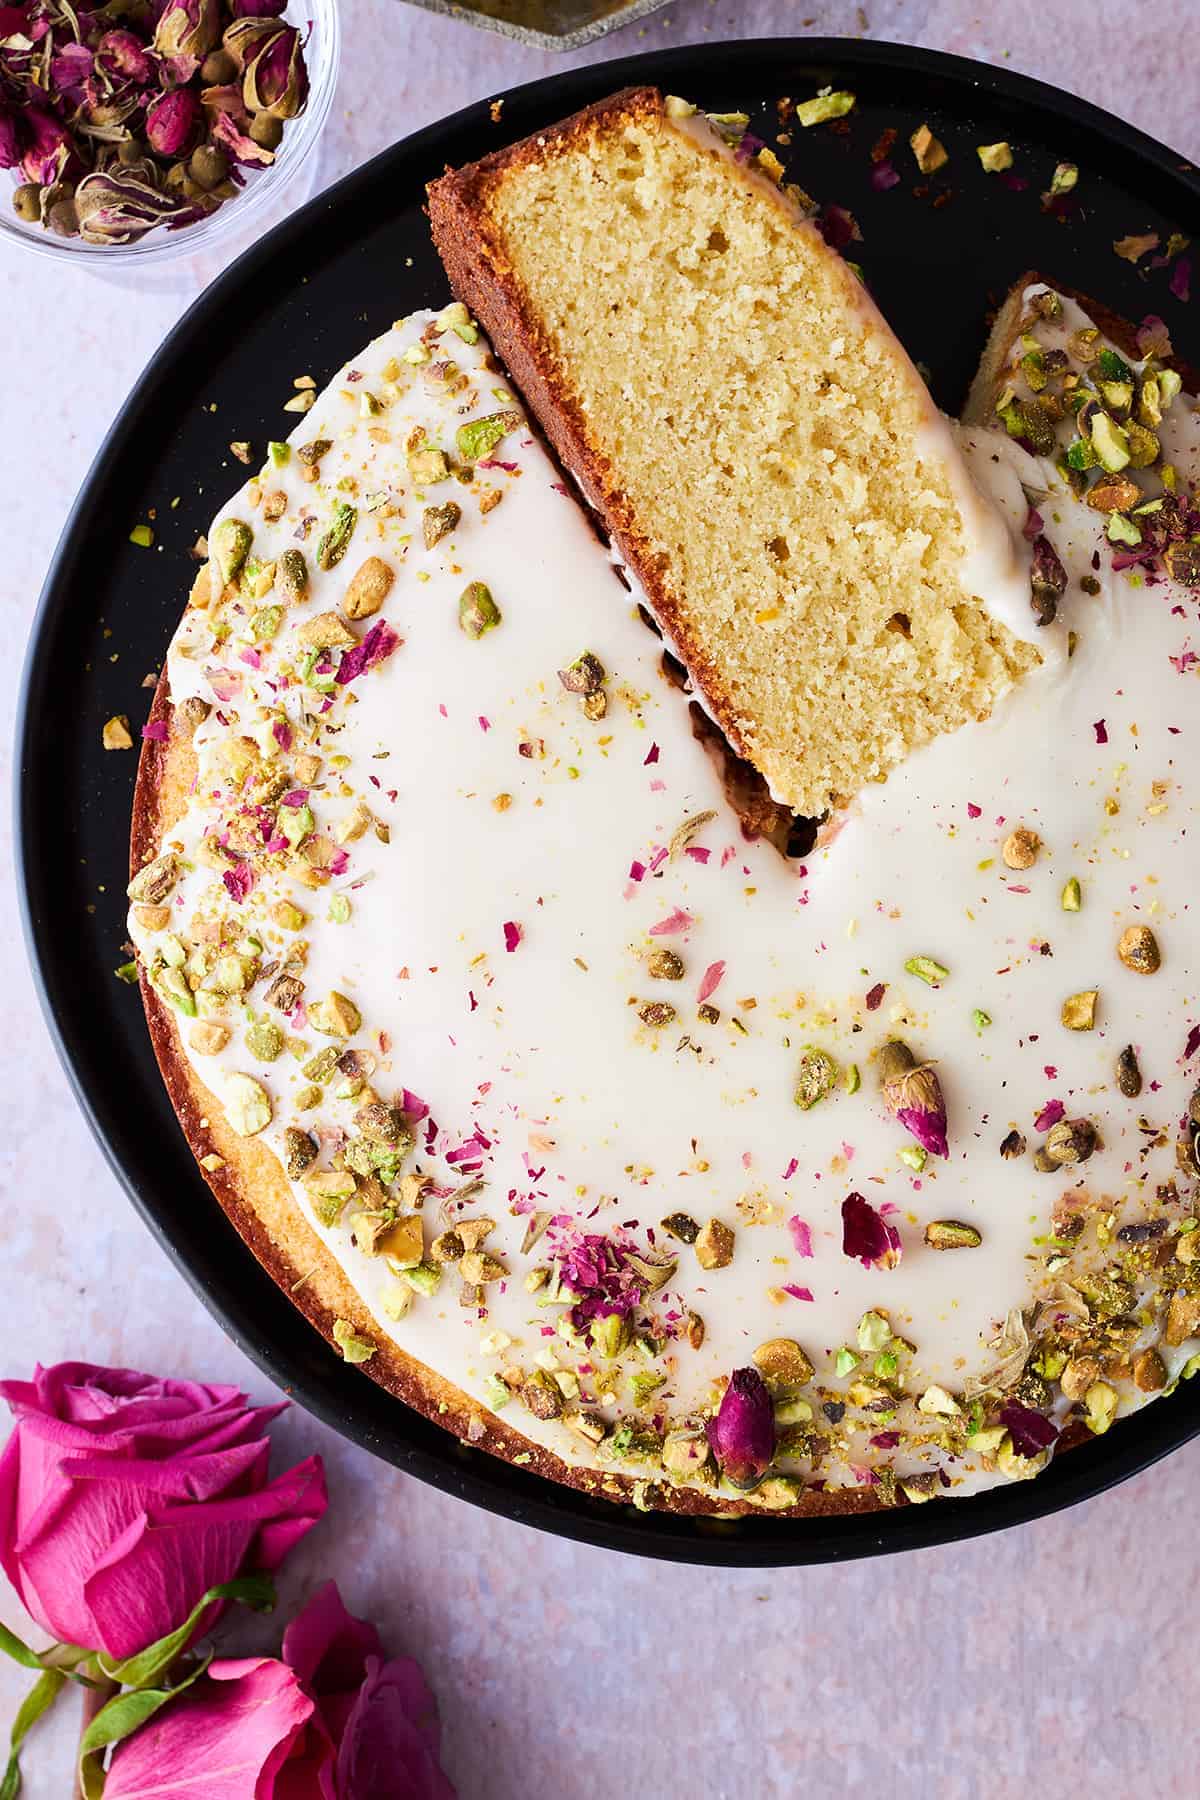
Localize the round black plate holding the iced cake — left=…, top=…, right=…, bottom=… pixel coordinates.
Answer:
left=18, top=40, right=1200, bottom=1566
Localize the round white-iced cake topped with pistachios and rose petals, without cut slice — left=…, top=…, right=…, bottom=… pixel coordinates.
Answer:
left=130, top=116, right=1200, bottom=1516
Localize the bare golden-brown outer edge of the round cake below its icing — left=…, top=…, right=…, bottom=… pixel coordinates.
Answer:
left=130, top=670, right=883, bottom=1517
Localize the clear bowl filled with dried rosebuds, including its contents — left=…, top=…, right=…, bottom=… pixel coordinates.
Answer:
left=0, top=0, right=340, bottom=263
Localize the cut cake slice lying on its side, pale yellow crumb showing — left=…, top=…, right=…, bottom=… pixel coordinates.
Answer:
left=430, top=88, right=1038, bottom=817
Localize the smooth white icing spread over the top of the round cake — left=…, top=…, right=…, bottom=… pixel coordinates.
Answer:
left=131, top=298, right=1200, bottom=1485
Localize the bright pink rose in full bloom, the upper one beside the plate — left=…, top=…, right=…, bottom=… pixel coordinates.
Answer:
left=0, top=1363, right=327, bottom=1658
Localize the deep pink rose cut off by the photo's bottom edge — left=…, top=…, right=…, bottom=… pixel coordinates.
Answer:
left=104, top=1582, right=455, bottom=1800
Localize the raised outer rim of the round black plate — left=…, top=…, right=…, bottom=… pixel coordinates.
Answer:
left=13, top=36, right=1200, bottom=1568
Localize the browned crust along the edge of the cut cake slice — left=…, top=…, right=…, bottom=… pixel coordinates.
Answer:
left=428, top=88, right=752, bottom=781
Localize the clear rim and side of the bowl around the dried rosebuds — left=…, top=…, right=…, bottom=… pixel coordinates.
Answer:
left=0, top=0, right=342, bottom=275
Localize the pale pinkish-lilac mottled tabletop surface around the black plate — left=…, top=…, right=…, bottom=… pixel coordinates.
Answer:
left=0, top=0, right=1200, bottom=1800
